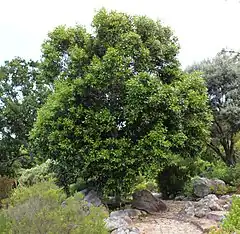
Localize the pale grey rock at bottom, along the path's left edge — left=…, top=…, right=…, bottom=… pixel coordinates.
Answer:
left=105, top=216, right=132, bottom=232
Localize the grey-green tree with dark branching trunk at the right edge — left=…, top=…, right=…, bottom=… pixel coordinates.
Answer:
left=188, top=50, right=240, bottom=165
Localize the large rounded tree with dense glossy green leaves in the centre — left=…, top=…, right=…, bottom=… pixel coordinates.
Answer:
left=31, top=9, right=210, bottom=194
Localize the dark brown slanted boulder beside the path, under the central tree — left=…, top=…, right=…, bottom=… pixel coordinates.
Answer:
left=132, top=190, right=167, bottom=214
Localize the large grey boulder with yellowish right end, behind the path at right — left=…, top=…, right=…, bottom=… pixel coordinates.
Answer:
left=193, top=177, right=227, bottom=197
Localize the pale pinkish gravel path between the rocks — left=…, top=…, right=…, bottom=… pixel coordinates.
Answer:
left=134, top=201, right=216, bottom=234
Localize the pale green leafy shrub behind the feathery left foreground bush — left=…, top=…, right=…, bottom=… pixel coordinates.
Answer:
left=18, top=159, right=54, bottom=186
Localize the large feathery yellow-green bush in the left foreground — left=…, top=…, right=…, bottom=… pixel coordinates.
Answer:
left=0, top=181, right=107, bottom=234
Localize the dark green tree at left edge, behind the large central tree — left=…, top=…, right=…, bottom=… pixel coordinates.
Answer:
left=0, top=58, right=48, bottom=175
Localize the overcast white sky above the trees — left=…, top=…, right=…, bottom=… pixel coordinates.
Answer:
left=0, top=0, right=240, bottom=67
